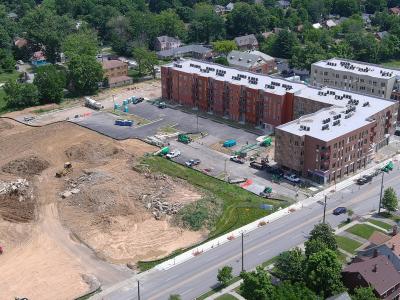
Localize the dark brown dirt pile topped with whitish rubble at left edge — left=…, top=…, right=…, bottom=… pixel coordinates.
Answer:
left=0, top=179, right=36, bottom=223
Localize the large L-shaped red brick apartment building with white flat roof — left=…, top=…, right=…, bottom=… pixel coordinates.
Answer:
left=161, top=60, right=398, bottom=183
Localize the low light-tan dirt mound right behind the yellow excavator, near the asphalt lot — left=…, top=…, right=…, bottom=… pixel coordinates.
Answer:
left=65, top=141, right=124, bottom=163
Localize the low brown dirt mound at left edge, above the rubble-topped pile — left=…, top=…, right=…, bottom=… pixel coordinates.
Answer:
left=1, top=156, right=50, bottom=176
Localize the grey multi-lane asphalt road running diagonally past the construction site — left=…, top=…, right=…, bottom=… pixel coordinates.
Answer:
left=95, top=163, right=400, bottom=300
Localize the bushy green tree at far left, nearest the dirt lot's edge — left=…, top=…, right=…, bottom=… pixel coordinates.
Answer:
left=4, top=81, right=39, bottom=109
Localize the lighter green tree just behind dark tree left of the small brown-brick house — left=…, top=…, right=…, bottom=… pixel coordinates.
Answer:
left=62, top=30, right=99, bottom=58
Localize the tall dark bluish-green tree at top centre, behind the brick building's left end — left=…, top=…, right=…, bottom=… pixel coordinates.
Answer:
left=188, top=3, right=225, bottom=43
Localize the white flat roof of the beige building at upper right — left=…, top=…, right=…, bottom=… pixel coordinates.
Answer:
left=313, top=58, right=400, bottom=79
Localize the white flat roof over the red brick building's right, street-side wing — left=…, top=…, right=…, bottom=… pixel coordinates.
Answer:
left=277, top=87, right=395, bottom=141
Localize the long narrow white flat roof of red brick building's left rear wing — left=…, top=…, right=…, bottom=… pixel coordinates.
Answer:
left=165, top=60, right=307, bottom=95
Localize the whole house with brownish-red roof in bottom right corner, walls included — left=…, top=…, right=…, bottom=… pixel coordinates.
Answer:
left=342, top=255, right=400, bottom=299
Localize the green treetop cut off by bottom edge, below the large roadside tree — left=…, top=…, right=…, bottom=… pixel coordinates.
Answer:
left=268, top=281, right=319, bottom=300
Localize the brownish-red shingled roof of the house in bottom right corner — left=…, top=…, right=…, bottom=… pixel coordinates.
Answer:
left=343, top=255, right=400, bottom=295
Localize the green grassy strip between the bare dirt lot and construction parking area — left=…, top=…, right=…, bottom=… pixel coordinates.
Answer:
left=139, top=156, right=288, bottom=271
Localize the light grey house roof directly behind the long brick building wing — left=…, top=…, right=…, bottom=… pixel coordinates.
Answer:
left=227, top=50, right=274, bottom=69
